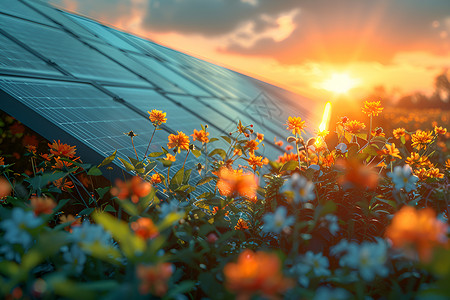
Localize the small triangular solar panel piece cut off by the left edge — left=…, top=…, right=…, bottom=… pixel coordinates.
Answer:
left=0, top=34, right=61, bottom=74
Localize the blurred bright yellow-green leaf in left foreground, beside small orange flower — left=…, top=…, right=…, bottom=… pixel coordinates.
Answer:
left=93, top=212, right=145, bottom=258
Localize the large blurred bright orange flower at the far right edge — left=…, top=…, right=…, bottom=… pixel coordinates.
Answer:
left=386, top=206, right=447, bottom=261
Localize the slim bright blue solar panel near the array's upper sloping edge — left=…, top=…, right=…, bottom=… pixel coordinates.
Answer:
left=66, top=14, right=140, bottom=52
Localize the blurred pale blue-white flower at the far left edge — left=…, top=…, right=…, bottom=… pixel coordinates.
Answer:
left=0, top=207, right=42, bottom=249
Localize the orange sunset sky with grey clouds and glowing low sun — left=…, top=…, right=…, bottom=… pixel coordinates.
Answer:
left=48, top=0, right=450, bottom=99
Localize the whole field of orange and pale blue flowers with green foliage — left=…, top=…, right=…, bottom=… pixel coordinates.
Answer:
left=0, top=101, right=450, bottom=300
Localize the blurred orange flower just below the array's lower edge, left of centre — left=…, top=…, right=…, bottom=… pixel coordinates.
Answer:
left=111, top=176, right=152, bottom=203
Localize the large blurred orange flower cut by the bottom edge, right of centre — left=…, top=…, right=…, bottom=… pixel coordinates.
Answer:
left=223, top=249, right=293, bottom=300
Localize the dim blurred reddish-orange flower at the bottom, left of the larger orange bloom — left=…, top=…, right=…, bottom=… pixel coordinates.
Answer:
left=136, top=263, right=173, bottom=297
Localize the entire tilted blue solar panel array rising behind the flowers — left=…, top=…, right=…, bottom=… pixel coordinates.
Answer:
left=0, top=0, right=323, bottom=192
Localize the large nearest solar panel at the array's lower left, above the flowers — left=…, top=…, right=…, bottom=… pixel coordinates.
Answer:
left=0, top=77, right=207, bottom=193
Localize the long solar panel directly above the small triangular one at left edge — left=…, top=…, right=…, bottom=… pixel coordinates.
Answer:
left=0, top=15, right=146, bottom=85
